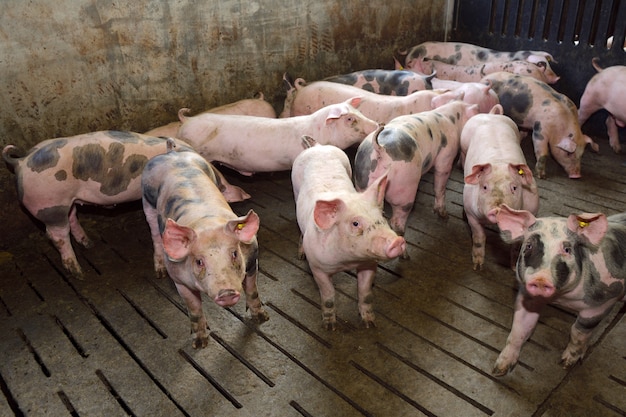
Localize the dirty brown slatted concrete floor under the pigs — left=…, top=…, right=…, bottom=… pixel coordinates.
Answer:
left=0, top=139, right=626, bottom=417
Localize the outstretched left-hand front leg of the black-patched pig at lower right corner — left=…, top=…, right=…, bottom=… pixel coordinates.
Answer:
left=492, top=293, right=543, bottom=376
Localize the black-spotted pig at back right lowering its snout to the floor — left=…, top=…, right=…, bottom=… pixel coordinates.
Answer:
left=482, top=72, right=598, bottom=178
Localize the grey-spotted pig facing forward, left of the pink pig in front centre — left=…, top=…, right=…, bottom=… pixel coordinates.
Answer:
left=141, top=143, right=269, bottom=349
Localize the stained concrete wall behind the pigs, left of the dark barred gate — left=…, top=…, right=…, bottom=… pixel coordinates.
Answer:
left=0, top=0, right=449, bottom=148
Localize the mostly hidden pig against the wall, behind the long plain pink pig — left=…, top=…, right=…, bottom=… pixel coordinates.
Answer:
left=145, top=92, right=276, bottom=137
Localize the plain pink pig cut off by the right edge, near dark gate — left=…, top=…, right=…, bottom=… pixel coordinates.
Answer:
left=578, top=58, right=626, bottom=153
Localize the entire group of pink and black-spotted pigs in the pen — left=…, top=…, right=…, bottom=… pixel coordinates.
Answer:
left=3, top=42, right=626, bottom=376
